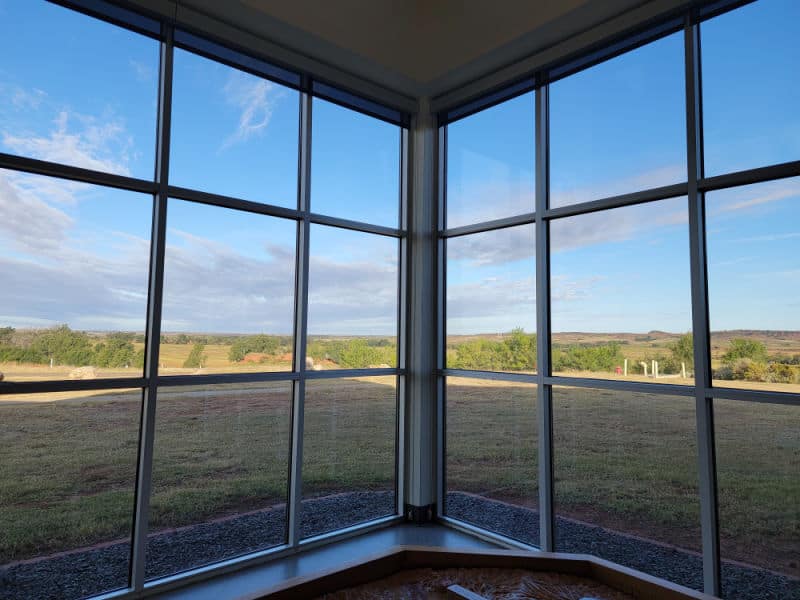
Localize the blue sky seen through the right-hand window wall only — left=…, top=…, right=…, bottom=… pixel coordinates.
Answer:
left=447, top=0, right=800, bottom=334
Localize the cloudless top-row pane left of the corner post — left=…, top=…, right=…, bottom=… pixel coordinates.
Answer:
left=311, top=98, right=400, bottom=227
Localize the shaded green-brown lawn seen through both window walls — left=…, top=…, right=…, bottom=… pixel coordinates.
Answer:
left=0, top=377, right=800, bottom=574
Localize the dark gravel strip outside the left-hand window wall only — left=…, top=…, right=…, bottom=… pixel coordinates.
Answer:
left=0, top=492, right=395, bottom=600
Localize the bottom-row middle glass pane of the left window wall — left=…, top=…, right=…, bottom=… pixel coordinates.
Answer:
left=147, top=382, right=292, bottom=579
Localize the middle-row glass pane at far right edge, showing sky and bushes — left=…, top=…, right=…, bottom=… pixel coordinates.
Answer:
left=706, top=177, right=800, bottom=392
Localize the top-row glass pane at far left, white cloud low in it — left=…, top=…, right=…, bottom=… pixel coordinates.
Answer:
left=0, top=0, right=159, bottom=179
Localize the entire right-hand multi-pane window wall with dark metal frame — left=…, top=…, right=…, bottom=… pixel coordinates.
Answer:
left=438, top=0, right=800, bottom=600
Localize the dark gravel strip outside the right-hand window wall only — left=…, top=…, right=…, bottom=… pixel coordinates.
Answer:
left=447, top=492, right=800, bottom=600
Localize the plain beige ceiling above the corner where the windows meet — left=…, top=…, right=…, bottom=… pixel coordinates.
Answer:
left=179, top=0, right=647, bottom=96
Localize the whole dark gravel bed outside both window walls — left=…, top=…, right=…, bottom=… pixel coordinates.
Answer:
left=0, top=492, right=800, bottom=600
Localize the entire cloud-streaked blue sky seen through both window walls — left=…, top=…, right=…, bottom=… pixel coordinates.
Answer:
left=0, top=0, right=800, bottom=335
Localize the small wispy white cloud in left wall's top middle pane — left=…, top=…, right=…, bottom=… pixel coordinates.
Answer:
left=220, top=71, right=282, bottom=150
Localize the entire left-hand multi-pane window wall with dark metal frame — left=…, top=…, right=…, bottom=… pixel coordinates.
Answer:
left=0, top=0, right=405, bottom=598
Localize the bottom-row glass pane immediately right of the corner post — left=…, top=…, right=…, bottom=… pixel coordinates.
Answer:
left=445, top=377, right=539, bottom=546
